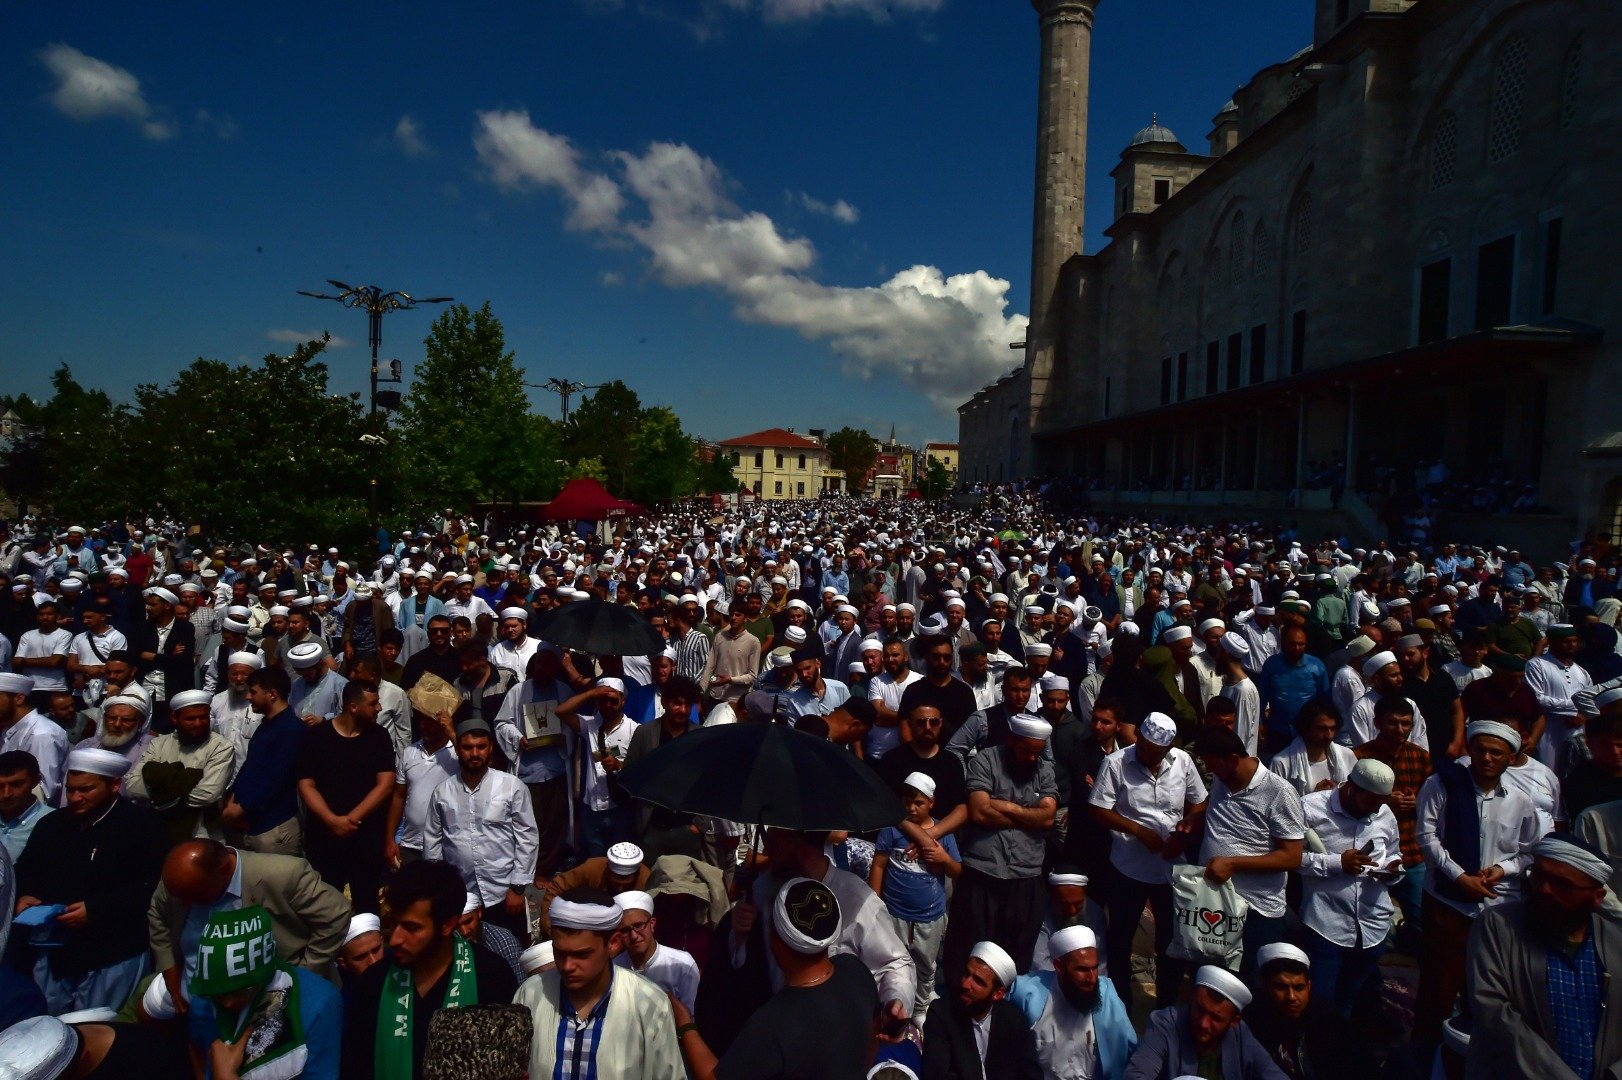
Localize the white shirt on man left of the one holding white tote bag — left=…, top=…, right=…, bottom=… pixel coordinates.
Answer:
left=1087, top=746, right=1205, bottom=885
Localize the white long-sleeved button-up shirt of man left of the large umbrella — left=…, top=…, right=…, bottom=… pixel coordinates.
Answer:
left=424, top=769, right=540, bottom=908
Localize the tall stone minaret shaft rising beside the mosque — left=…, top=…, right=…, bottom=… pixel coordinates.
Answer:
left=1019, top=0, right=1098, bottom=457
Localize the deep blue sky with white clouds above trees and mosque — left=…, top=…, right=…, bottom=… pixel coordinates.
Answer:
left=0, top=0, right=1312, bottom=441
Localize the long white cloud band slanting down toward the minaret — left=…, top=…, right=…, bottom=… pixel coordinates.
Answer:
left=474, top=112, right=1027, bottom=407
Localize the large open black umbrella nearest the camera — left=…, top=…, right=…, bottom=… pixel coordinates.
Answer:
left=620, top=720, right=902, bottom=832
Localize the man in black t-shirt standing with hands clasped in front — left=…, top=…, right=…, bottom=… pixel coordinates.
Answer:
left=295, top=679, right=394, bottom=913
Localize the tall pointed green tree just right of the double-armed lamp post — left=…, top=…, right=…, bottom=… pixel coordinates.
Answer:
left=394, top=302, right=535, bottom=509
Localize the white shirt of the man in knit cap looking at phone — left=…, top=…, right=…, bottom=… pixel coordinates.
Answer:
left=1301, top=788, right=1401, bottom=949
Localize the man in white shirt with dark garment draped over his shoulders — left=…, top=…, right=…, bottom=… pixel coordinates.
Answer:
left=1413, top=720, right=1538, bottom=1043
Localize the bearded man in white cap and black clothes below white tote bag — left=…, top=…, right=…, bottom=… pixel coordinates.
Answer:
left=1244, top=942, right=1375, bottom=1080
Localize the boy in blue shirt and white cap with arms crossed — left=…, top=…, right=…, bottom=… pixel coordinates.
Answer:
left=868, top=772, right=963, bottom=1025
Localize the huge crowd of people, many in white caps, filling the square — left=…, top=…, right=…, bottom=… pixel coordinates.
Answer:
left=0, top=490, right=1622, bottom=1080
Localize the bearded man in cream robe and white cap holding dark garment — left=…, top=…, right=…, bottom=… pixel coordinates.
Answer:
left=125, top=691, right=235, bottom=842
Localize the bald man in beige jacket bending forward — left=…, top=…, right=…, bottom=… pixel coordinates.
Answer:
left=146, top=840, right=350, bottom=1010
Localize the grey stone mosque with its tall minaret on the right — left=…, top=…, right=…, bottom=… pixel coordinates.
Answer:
left=959, top=0, right=1622, bottom=542
